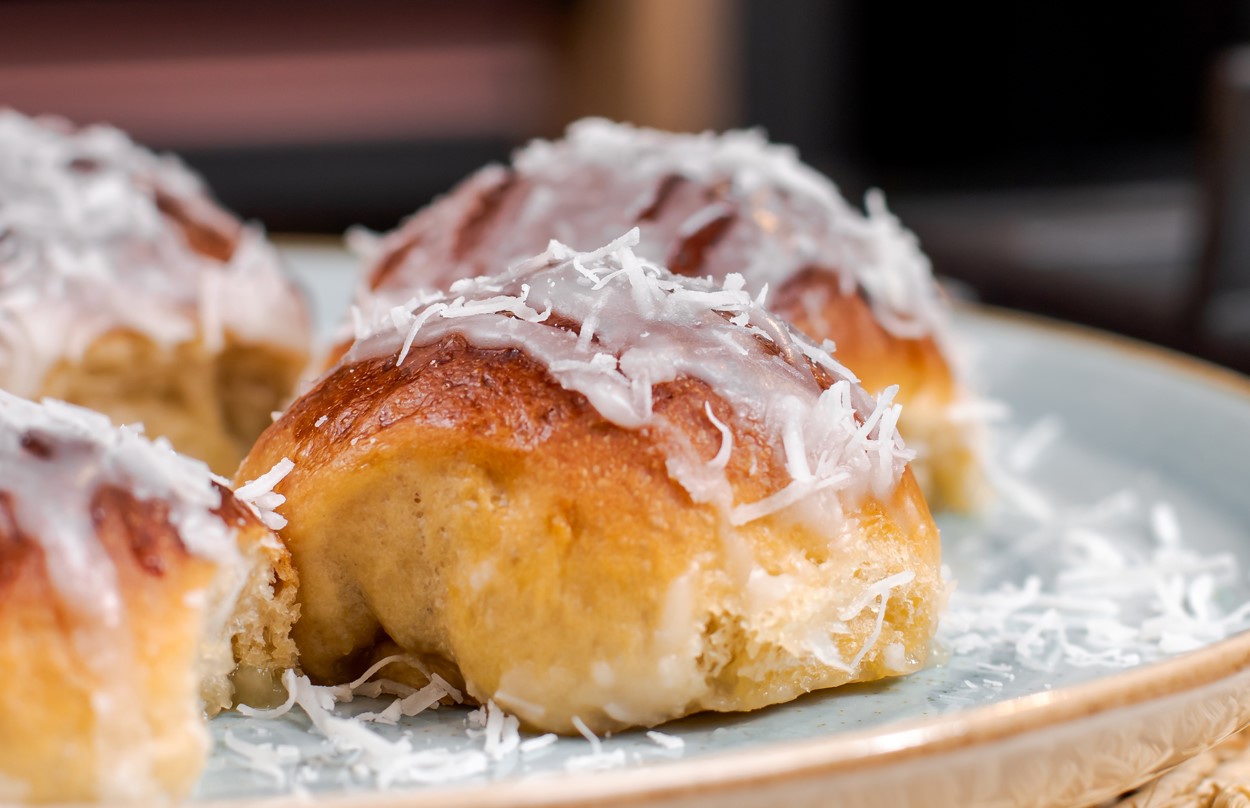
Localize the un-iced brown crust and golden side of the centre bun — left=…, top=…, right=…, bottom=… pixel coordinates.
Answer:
left=240, top=338, right=944, bottom=733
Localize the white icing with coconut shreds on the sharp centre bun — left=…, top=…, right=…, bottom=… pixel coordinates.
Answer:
left=344, top=229, right=911, bottom=522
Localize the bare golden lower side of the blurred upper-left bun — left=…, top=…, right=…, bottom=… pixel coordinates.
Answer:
left=34, top=330, right=308, bottom=475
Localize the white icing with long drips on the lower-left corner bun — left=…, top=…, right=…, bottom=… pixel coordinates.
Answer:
left=0, top=391, right=255, bottom=800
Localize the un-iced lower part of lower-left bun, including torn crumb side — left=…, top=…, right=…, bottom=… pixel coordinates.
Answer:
left=0, top=488, right=295, bottom=804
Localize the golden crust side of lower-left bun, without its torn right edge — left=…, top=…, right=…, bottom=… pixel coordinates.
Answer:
left=0, top=487, right=215, bottom=802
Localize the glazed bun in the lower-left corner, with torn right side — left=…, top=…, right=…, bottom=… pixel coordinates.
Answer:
left=0, top=391, right=295, bottom=803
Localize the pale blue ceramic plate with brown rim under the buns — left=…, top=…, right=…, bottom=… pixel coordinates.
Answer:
left=195, top=244, right=1250, bottom=808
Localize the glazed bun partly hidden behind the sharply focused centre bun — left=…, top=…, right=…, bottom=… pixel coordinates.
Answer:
left=355, top=119, right=981, bottom=509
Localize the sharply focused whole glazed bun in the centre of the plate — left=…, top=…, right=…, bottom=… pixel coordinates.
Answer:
left=240, top=230, right=944, bottom=733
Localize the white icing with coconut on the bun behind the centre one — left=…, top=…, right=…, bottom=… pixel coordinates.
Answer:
left=354, top=119, right=945, bottom=338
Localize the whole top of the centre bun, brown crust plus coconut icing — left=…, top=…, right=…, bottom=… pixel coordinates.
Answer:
left=278, top=230, right=910, bottom=547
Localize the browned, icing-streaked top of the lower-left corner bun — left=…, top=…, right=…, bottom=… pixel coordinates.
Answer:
left=0, top=391, right=255, bottom=607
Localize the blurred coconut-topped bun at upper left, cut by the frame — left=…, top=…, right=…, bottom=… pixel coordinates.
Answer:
left=0, top=109, right=310, bottom=474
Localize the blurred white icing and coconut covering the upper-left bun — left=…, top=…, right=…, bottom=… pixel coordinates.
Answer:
left=0, top=109, right=310, bottom=395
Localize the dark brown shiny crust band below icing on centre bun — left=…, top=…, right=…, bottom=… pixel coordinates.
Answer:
left=258, top=334, right=805, bottom=512
